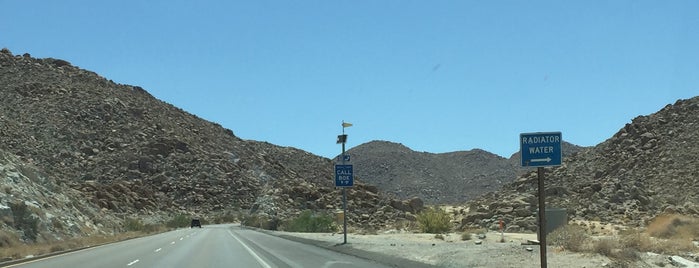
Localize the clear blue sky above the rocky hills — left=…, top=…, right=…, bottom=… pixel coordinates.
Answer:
left=0, top=0, right=699, bottom=157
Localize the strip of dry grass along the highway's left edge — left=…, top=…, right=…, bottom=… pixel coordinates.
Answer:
left=0, top=231, right=152, bottom=259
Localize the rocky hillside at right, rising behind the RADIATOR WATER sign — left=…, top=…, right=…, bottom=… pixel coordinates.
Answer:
left=463, top=97, right=699, bottom=231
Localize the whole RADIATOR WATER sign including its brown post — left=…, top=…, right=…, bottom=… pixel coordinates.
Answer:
left=519, top=132, right=563, bottom=268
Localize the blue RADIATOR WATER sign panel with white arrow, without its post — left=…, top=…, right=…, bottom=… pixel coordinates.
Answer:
left=519, top=132, right=563, bottom=167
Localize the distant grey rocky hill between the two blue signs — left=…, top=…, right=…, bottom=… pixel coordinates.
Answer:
left=347, top=141, right=516, bottom=204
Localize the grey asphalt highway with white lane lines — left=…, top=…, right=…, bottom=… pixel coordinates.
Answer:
left=7, top=225, right=391, bottom=268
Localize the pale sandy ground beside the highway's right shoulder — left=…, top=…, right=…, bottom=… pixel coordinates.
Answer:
left=275, top=229, right=611, bottom=268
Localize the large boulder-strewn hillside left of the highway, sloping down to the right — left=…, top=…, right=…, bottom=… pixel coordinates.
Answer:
left=0, top=49, right=419, bottom=243
